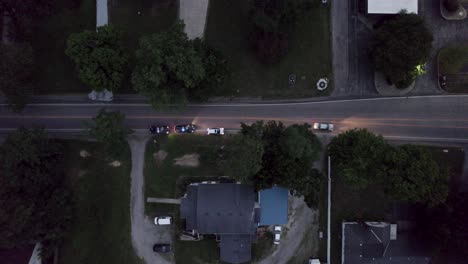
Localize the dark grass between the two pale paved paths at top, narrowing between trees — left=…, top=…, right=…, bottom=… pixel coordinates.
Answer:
left=109, top=0, right=178, bottom=93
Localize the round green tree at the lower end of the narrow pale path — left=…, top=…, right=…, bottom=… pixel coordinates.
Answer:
left=65, top=26, right=128, bottom=91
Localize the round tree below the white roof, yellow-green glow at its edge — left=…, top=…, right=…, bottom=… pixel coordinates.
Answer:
left=372, top=13, right=433, bottom=88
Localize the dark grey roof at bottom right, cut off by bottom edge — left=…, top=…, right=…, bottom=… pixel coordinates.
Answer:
left=342, top=222, right=431, bottom=264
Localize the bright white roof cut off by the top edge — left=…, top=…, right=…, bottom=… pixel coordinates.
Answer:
left=367, top=0, right=418, bottom=14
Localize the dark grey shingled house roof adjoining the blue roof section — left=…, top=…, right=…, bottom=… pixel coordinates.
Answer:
left=180, top=183, right=260, bottom=263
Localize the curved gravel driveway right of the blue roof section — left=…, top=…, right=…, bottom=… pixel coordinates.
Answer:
left=258, top=197, right=318, bottom=264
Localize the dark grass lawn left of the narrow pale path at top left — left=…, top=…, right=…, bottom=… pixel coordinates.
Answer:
left=31, top=0, right=96, bottom=94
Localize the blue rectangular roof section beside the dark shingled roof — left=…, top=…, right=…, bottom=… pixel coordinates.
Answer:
left=258, top=186, right=288, bottom=226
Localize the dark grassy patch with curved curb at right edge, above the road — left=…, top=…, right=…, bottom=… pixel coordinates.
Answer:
left=438, top=45, right=468, bottom=93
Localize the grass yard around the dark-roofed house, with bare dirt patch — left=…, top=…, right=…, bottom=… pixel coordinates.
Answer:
left=144, top=135, right=272, bottom=264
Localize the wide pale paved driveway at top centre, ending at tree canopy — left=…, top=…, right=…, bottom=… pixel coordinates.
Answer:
left=179, top=0, right=208, bottom=39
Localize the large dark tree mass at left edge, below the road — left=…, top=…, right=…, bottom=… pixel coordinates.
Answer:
left=0, top=128, right=71, bottom=248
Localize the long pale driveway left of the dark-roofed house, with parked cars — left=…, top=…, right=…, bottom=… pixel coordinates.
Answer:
left=129, top=135, right=171, bottom=264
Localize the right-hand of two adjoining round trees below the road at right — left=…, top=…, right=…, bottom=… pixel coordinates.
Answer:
left=385, top=145, right=448, bottom=206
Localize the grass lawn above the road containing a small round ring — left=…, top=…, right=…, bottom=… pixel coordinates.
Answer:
left=205, top=0, right=332, bottom=98
